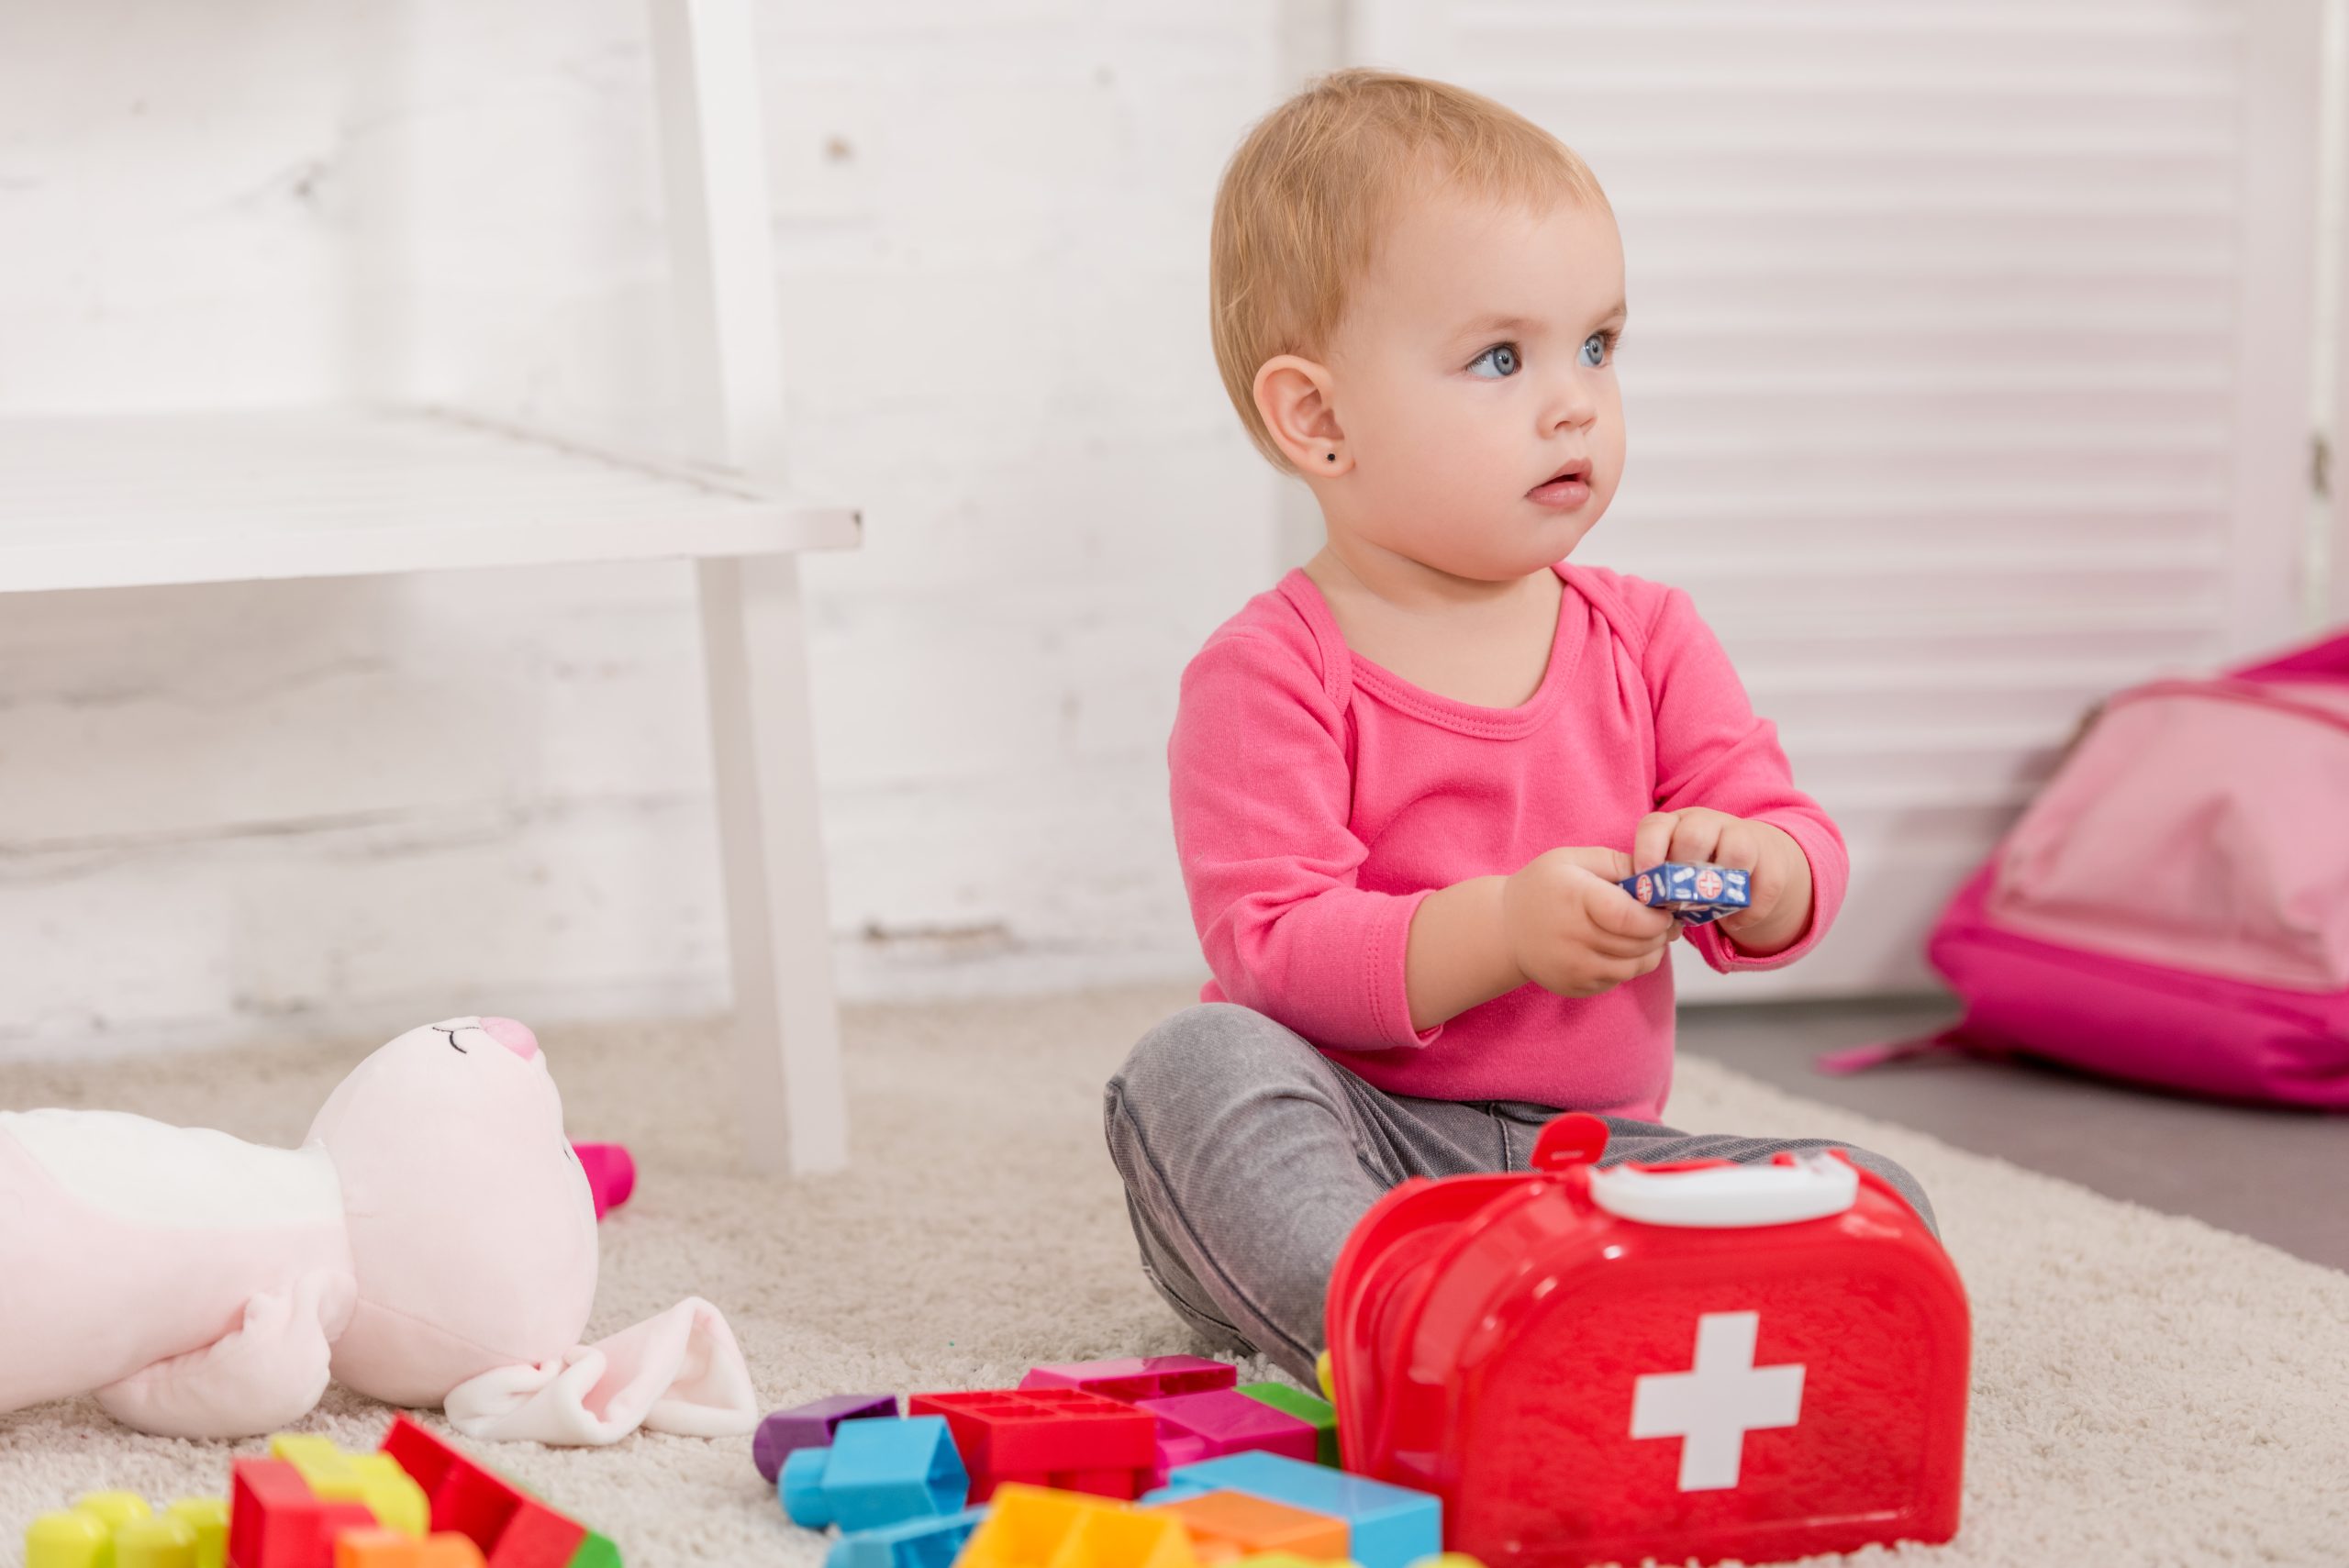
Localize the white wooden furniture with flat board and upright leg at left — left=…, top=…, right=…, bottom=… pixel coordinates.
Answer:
left=0, top=0, right=860, bottom=1172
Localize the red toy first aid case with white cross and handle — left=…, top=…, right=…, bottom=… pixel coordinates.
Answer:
left=1327, top=1115, right=1971, bottom=1568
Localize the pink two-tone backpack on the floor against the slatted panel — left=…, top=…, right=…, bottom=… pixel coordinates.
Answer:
left=1820, top=634, right=2349, bottom=1110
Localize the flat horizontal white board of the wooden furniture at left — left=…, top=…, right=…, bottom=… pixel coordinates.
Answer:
left=0, top=408, right=860, bottom=594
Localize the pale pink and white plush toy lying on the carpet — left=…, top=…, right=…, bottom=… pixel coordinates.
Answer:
left=0, top=1018, right=759, bottom=1443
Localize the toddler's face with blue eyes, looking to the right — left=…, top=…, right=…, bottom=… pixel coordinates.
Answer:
left=1301, top=193, right=1623, bottom=582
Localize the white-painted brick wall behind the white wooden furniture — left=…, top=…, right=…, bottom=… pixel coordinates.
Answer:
left=0, top=0, right=1285, bottom=1054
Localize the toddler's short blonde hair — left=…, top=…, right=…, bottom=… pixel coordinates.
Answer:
left=1208, top=71, right=1607, bottom=470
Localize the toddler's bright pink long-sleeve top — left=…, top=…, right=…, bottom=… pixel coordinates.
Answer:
left=1167, top=563, right=1849, bottom=1119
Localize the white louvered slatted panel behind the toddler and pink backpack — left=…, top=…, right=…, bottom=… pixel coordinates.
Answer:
left=1355, top=0, right=2319, bottom=997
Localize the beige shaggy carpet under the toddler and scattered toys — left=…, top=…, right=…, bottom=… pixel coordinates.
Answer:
left=0, top=991, right=2349, bottom=1568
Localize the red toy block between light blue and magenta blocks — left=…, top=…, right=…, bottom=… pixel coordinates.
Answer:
left=907, top=1387, right=1158, bottom=1502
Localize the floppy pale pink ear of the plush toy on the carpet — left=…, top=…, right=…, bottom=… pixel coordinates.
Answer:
left=441, top=1296, right=759, bottom=1446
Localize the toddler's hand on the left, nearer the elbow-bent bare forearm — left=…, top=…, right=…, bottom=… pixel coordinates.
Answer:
left=1501, top=848, right=1679, bottom=995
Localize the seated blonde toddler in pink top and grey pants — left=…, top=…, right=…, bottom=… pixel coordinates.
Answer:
left=1104, top=71, right=1931, bottom=1383
